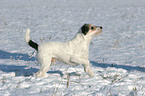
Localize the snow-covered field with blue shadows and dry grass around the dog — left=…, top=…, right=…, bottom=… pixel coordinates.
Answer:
left=0, top=0, right=145, bottom=96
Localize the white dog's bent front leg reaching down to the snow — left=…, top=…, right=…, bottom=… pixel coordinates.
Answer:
left=70, top=56, right=94, bottom=77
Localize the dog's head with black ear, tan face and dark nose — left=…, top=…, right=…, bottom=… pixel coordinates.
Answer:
left=81, top=24, right=102, bottom=36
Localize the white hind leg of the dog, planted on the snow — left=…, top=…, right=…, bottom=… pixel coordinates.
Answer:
left=36, top=57, right=51, bottom=77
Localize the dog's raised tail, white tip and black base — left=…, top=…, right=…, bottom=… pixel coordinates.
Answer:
left=25, top=29, right=39, bottom=51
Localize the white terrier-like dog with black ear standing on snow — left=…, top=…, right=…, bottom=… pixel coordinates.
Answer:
left=25, top=24, right=102, bottom=77
